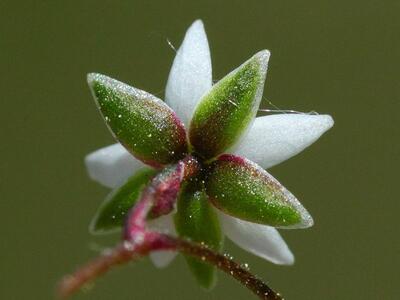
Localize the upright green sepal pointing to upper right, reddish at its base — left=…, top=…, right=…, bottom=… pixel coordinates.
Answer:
left=189, top=50, right=269, bottom=159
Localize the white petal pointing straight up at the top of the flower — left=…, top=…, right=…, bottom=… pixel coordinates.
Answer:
left=165, top=20, right=212, bottom=128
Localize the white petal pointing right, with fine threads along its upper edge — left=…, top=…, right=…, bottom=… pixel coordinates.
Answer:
left=235, top=114, right=334, bottom=169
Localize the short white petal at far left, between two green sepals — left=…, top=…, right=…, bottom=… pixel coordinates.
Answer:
left=85, top=143, right=144, bottom=188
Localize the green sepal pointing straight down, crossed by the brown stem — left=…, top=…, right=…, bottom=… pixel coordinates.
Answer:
left=174, top=179, right=223, bottom=289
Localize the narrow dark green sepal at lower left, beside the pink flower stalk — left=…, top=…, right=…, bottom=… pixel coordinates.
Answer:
left=89, top=168, right=157, bottom=234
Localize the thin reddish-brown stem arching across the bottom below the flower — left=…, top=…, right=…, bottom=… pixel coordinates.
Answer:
left=57, top=232, right=283, bottom=300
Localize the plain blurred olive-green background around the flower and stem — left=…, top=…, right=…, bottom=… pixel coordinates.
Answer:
left=0, top=0, right=400, bottom=299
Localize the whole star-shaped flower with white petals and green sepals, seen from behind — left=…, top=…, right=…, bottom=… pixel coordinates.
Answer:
left=85, top=21, right=333, bottom=288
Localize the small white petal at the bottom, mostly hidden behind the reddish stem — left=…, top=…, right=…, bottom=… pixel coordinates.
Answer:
left=148, top=214, right=176, bottom=268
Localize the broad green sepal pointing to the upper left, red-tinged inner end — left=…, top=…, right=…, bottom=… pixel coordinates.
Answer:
left=88, top=73, right=187, bottom=167
